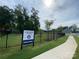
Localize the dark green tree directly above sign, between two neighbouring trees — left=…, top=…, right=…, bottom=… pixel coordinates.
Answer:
left=23, top=8, right=33, bottom=30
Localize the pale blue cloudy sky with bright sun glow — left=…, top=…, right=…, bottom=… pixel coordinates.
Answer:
left=0, top=0, right=79, bottom=29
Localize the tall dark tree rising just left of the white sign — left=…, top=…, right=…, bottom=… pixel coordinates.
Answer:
left=14, top=5, right=24, bottom=32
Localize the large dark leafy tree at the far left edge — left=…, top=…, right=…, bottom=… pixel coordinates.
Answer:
left=0, top=6, right=13, bottom=48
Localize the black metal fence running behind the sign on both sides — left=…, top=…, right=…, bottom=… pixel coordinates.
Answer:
left=0, top=31, right=65, bottom=48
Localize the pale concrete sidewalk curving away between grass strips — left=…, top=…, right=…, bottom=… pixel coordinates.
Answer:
left=32, top=36, right=77, bottom=59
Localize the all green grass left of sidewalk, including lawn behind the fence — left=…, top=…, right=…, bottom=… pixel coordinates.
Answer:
left=0, top=34, right=67, bottom=59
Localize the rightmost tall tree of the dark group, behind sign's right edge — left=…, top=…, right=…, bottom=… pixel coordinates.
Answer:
left=30, top=8, right=40, bottom=33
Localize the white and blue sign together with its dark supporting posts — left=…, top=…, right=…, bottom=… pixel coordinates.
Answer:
left=21, top=30, right=35, bottom=49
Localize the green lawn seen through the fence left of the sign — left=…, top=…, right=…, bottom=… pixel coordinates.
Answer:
left=0, top=34, right=21, bottom=47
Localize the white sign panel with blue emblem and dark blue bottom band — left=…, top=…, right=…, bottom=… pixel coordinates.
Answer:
left=23, top=30, right=34, bottom=44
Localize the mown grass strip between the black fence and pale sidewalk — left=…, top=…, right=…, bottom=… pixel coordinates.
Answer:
left=0, top=35, right=67, bottom=59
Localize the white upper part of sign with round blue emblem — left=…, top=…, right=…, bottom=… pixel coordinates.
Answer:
left=23, top=30, right=34, bottom=40
